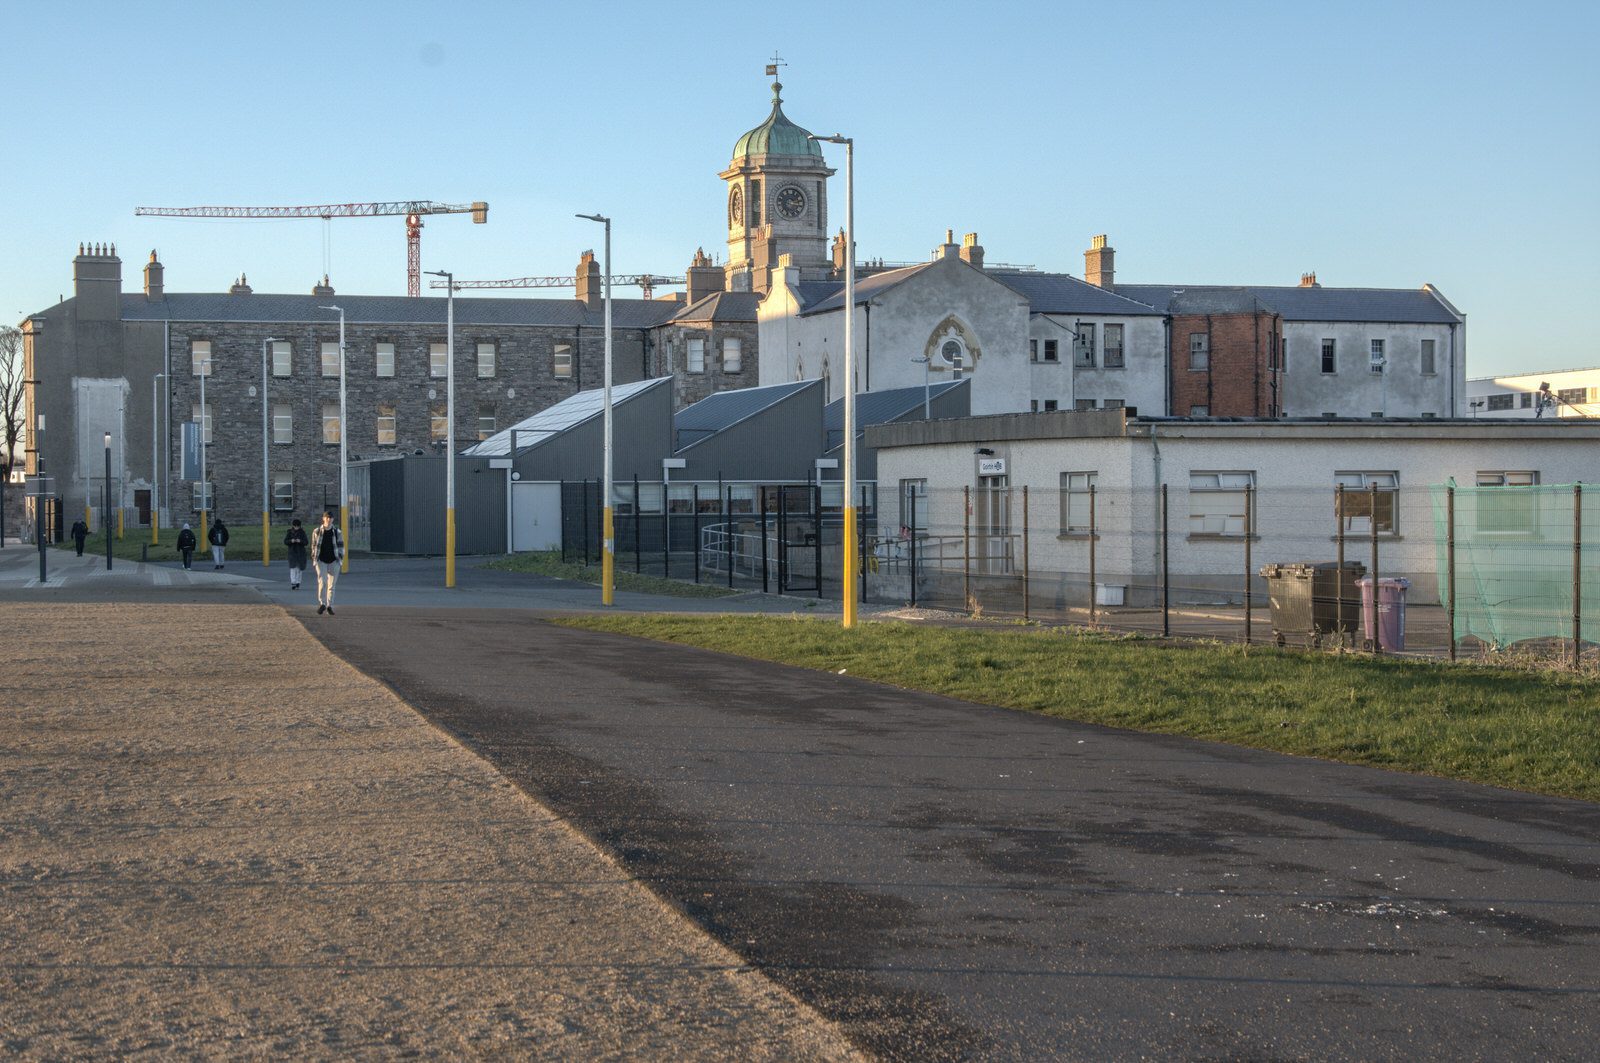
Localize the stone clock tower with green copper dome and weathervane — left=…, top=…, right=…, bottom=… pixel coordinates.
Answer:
left=718, top=80, right=834, bottom=291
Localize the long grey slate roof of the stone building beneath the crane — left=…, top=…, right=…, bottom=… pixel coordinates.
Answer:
left=122, top=291, right=682, bottom=328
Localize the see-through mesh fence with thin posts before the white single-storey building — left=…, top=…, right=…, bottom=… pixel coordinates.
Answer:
left=862, top=474, right=1600, bottom=663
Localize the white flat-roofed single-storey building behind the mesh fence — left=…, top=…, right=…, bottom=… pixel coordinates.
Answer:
left=867, top=410, right=1600, bottom=604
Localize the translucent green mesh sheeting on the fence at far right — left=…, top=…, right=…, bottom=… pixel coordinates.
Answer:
left=1432, top=483, right=1600, bottom=647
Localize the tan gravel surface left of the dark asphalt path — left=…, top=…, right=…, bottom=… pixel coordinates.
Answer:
left=0, top=604, right=856, bottom=1060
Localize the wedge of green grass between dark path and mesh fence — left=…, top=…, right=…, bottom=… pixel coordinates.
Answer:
left=555, top=615, right=1600, bottom=800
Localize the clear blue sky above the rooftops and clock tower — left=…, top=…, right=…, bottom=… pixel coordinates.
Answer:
left=0, top=0, right=1600, bottom=375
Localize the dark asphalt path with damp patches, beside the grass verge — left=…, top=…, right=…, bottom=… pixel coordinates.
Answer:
left=293, top=607, right=1600, bottom=1060
